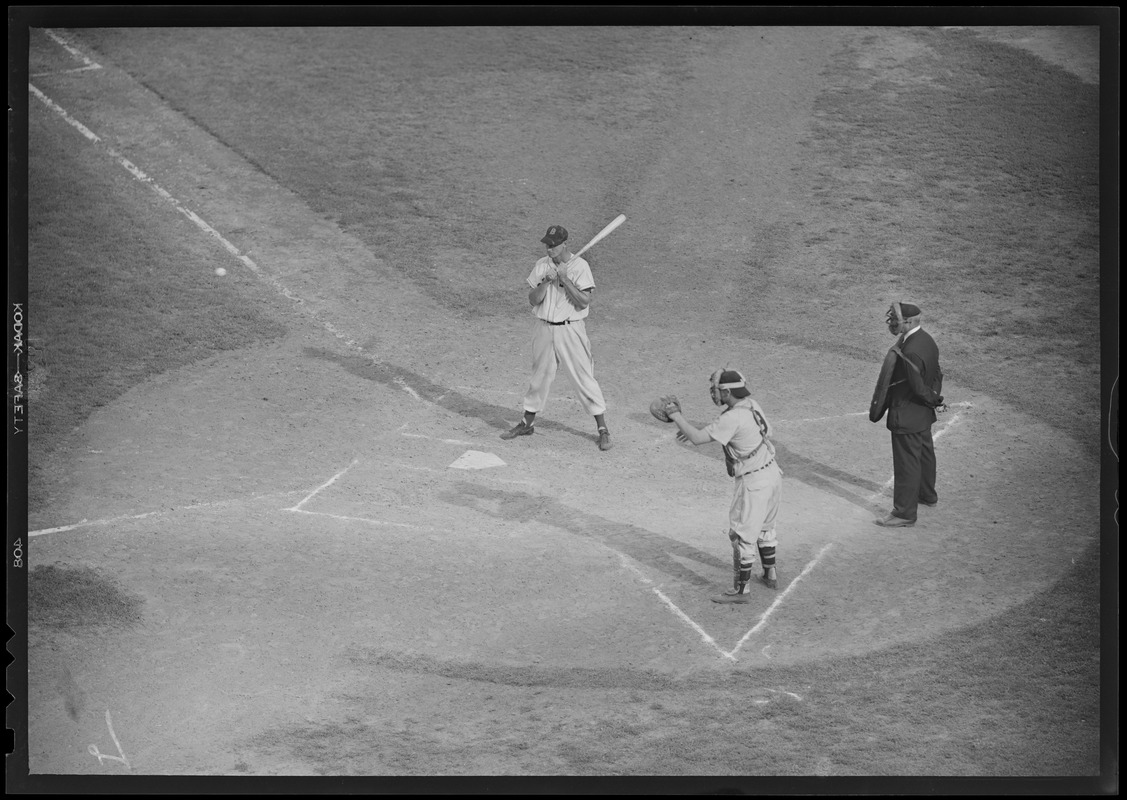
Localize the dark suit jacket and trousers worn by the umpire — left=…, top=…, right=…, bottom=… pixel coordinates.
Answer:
left=887, top=328, right=940, bottom=522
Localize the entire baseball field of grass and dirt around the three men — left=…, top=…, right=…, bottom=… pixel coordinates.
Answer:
left=9, top=15, right=1118, bottom=793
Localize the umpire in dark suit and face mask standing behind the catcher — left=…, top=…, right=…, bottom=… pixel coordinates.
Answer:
left=876, top=303, right=943, bottom=527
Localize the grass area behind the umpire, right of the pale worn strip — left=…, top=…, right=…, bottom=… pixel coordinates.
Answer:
left=772, top=34, right=1100, bottom=456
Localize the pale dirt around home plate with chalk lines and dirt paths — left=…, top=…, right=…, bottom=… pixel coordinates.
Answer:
left=21, top=21, right=1099, bottom=775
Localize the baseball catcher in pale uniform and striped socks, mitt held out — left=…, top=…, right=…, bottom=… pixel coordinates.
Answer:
left=651, top=370, right=782, bottom=603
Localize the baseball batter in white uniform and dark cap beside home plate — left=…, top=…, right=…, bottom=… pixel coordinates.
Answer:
left=500, top=225, right=611, bottom=450
